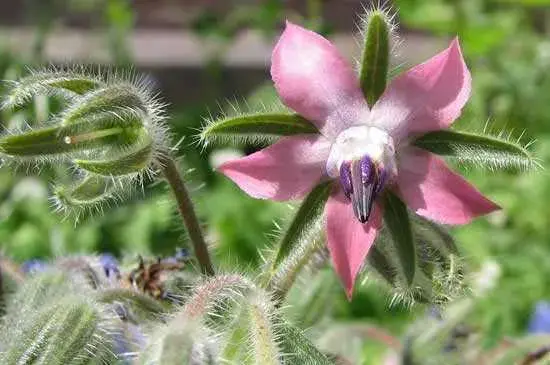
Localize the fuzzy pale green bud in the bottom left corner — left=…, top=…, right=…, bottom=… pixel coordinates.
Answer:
left=0, top=271, right=118, bottom=365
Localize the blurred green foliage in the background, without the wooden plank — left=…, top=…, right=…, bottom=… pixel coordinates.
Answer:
left=0, top=0, right=550, bottom=363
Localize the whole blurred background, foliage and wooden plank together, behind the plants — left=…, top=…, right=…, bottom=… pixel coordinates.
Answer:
left=0, top=0, right=550, bottom=357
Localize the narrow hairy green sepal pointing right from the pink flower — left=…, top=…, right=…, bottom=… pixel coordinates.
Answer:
left=414, top=130, right=539, bottom=170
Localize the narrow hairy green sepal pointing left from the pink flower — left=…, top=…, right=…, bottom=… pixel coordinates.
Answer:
left=200, top=113, right=318, bottom=142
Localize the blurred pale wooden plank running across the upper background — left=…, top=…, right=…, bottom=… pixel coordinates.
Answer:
left=0, top=28, right=447, bottom=68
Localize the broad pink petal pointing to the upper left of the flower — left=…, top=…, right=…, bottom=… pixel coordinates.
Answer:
left=271, top=22, right=368, bottom=137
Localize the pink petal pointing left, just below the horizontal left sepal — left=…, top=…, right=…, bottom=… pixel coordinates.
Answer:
left=220, top=135, right=330, bottom=200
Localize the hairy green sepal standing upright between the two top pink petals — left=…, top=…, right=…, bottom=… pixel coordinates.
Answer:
left=359, top=10, right=392, bottom=107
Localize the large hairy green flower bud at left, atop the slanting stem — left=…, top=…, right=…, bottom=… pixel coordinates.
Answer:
left=0, top=70, right=169, bottom=216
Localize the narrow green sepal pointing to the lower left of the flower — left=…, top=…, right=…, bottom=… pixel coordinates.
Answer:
left=273, top=181, right=332, bottom=266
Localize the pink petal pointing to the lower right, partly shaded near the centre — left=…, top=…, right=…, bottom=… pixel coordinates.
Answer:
left=397, top=147, right=500, bottom=224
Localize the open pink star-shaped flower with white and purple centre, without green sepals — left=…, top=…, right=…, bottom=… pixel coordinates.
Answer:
left=220, top=23, right=499, bottom=297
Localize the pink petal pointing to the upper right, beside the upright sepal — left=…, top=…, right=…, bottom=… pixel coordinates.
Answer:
left=371, top=39, right=472, bottom=140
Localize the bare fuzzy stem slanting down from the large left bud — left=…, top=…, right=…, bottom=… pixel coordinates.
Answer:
left=162, top=155, right=214, bottom=276
